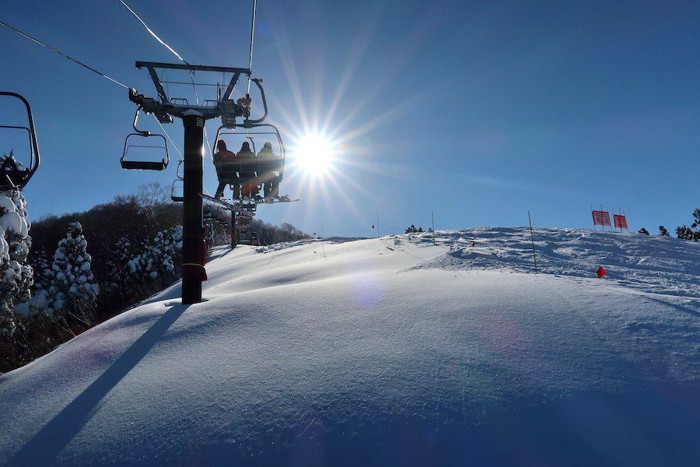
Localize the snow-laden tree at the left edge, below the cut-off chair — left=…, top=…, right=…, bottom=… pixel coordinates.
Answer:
left=0, top=190, right=34, bottom=334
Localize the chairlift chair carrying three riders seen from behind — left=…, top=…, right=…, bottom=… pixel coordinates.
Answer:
left=214, top=123, right=285, bottom=198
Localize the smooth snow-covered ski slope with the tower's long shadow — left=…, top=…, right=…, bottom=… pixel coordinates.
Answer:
left=0, top=228, right=700, bottom=466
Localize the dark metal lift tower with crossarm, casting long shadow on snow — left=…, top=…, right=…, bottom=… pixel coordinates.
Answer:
left=128, top=62, right=254, bottom=304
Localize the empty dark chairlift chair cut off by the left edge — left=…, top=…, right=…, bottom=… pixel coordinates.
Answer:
left=0, top=91, right=41, bottom=191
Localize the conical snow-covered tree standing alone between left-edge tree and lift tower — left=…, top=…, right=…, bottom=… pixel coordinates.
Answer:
left=47, top=222, right=99, bottom=325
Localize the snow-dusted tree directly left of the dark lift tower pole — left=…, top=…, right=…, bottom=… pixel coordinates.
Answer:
left=129, top=226, right=182, bottom=281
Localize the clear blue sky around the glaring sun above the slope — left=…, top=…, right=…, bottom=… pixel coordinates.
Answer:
left=0, top=0, right=700, bottom=235
